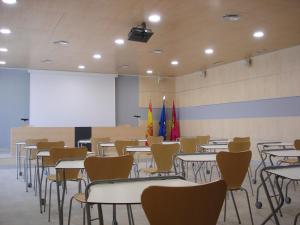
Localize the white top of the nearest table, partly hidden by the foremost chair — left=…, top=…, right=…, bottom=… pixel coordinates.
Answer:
left=88, top=179, right=198, bottom=204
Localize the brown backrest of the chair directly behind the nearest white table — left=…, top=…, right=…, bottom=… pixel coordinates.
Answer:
left=84, top=155, right=133, bottom=181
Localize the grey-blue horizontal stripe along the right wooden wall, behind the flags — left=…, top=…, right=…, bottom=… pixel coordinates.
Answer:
left=140, top=96, right=300, bottom=120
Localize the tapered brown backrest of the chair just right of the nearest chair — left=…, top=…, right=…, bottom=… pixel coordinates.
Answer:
left=217, top=151, right=252, bottom=190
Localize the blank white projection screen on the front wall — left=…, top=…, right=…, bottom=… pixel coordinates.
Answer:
left=30, top=70, right=116, bottom=127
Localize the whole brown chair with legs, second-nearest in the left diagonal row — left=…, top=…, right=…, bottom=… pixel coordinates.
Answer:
left=47, top=147, right=87, bottom=222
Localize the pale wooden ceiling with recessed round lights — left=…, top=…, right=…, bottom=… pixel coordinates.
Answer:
left=0, top=0, right=300, bottom=76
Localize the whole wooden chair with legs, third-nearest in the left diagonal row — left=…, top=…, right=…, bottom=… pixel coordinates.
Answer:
left=36, top=141, right=65, bottom=212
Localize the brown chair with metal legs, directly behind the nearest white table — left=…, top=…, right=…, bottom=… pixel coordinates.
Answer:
left=68, top=155, right=133, bottom=225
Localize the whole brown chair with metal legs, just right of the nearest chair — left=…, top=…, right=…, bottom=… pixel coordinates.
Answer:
left=217, top=151, right=254, bottom=225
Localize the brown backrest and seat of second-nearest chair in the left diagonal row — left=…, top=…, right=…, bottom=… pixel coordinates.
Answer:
left=50, top=147, right=87, bottom=180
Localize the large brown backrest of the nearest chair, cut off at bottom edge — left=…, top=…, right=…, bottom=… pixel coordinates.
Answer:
left=141, top=180, right=226, bottom=225
